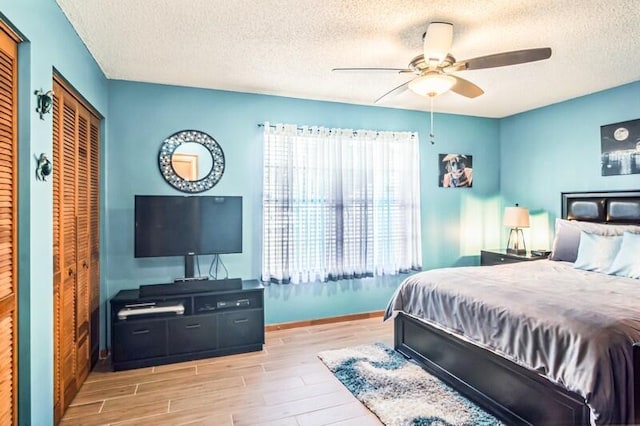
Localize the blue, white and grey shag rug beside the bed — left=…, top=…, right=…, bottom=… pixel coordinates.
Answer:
left=318, top=343, right=502, bottom=426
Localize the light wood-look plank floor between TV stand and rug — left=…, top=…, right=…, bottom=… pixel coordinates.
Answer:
left=61, top=317, right=393, bottom=426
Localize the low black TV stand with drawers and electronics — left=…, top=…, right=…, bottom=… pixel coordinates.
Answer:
left=111, top=280, right=264, bottom=370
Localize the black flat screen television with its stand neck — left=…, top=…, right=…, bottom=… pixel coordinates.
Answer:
left=134, top=195, right=242, bottom=278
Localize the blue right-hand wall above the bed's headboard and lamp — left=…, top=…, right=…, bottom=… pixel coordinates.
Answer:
left=500, top=82, right=640, bottom=245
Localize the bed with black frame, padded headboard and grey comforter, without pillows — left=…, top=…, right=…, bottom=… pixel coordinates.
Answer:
left=386, top=191, right=640, bottom=425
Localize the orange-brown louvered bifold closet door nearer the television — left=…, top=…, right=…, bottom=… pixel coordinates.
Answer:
left=53, top=78, right=100, bottom=422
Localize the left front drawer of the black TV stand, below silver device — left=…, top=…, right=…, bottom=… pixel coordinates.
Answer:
left=112, top=319, right=167, bottom=362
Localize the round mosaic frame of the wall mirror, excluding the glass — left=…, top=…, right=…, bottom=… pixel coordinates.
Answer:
left=158, top=130, right=224, bottom=193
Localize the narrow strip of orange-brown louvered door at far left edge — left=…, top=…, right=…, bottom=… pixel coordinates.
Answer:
left=0, top=22, right=18, bottom=425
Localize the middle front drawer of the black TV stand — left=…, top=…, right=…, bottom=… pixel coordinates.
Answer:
left=168, top=315, right=218, bottom=355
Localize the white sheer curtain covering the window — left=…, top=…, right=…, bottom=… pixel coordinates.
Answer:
left=262, top=123, right=422, bottom=283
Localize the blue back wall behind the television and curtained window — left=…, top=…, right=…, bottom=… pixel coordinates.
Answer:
left=102, top=81, right=499, bottom=323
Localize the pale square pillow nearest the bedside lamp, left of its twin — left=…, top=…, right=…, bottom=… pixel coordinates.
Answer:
left=573, top=231, right=622, bottom=274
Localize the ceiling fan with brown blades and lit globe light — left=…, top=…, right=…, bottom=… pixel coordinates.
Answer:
left=332, top=22, right=551, bottom=103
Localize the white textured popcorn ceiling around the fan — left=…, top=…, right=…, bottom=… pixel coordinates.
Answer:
left=57, top=0, right=640, bottom=117
